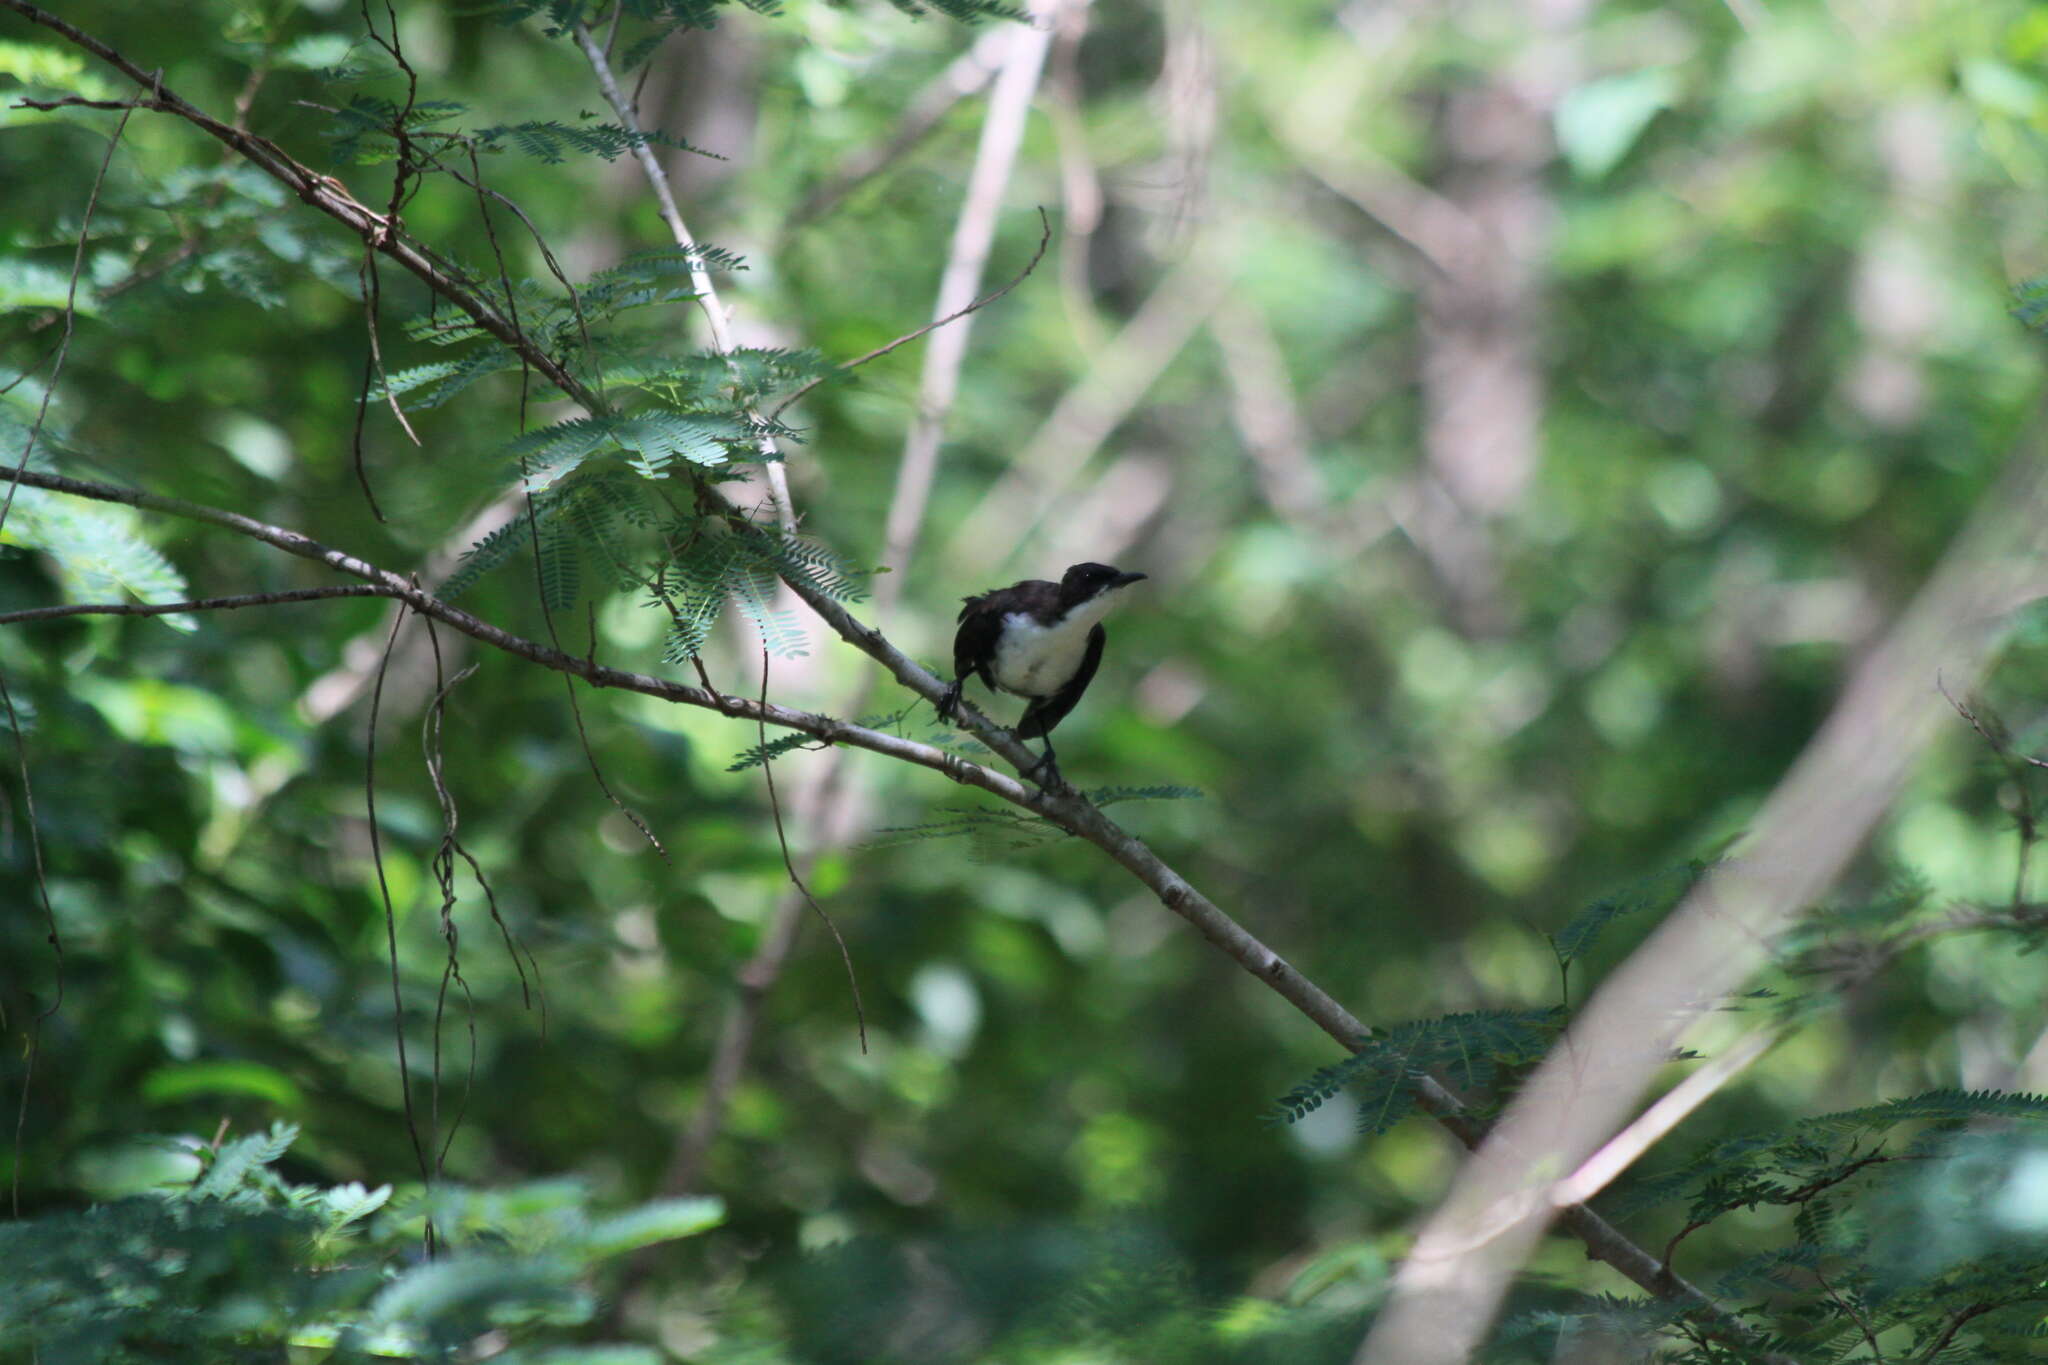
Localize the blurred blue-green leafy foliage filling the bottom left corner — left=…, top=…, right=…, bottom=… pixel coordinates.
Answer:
left=0, top=1124, right=723, bottom=1365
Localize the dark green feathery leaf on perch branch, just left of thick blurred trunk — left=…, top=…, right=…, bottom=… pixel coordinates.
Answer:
left=1276, top=1009, right=1565, bottom=1134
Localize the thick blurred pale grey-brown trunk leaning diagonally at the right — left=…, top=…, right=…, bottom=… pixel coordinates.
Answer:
left=1358, top=417, right=2048, bottom=1365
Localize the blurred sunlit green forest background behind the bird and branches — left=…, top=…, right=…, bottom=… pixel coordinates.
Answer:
left=0, top=0, right=2048, bottom=1361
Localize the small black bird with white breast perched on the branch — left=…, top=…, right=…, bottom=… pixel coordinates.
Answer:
left=938, top=563, right=1145, bottom=786
